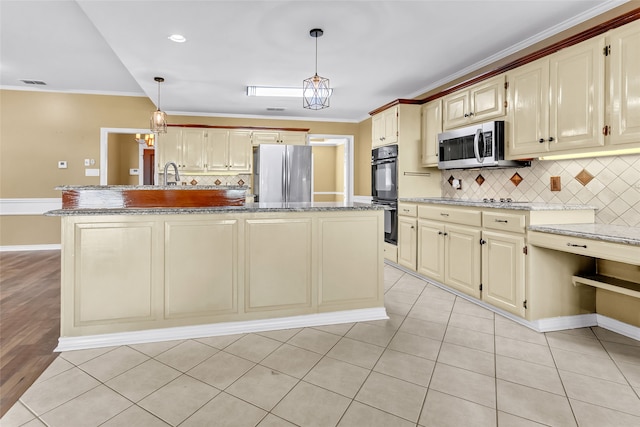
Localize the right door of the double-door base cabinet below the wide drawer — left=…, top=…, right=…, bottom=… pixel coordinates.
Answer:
left=445, top=225, right=481, bottom=298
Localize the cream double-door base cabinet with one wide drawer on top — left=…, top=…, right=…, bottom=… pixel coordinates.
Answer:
left=417, top=205, right=481, bottom=298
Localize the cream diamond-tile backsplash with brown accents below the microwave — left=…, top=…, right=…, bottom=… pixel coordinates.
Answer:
left=441, top=155, right=640, bottom=227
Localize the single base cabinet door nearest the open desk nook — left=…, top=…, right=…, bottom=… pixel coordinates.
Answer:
left=482, top=231, right=525, bottom=317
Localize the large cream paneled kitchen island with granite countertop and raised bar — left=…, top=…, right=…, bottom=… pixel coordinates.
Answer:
left=47, top=186, right=387, bottom=351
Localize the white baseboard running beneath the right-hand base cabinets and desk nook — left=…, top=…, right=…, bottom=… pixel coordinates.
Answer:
left=385, top=260, right=640, bottom=341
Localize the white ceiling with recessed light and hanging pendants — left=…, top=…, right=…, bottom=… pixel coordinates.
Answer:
left=0, top=0, right=625, bottom=122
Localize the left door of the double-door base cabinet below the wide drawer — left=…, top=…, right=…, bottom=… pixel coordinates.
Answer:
left=417, top=220, right=445, bottom=283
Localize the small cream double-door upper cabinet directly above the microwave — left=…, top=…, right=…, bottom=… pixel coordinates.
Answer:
left=442, top=74, right=507, bottom=130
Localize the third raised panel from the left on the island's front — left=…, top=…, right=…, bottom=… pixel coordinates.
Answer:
left=245, top=218, right=311, bottom=311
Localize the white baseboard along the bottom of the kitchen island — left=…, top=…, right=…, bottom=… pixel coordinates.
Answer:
left=54, top=307, right=389, bottom=351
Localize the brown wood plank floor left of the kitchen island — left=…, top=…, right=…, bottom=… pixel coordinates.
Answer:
left=0, top=250, right=60, bottom=417
